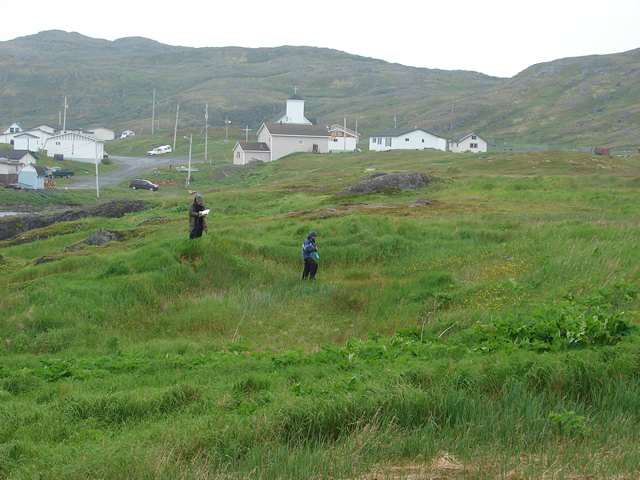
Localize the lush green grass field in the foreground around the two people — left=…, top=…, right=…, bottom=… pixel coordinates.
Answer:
left=0, top=151, right=640, bottom=480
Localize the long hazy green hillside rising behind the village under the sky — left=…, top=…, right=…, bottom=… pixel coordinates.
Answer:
left=0, top=31, right=640, bottom=146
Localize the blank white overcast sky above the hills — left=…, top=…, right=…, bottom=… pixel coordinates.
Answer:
left=0, top=0, right=640, bottom=77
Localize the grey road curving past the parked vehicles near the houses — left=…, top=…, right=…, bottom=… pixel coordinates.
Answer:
left=58, top=155, right=203, bottom=190
